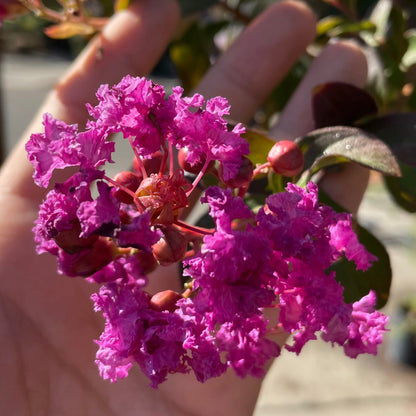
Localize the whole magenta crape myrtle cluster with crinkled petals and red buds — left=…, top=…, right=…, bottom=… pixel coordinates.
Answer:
left=26, top=76, right=387, bottom=387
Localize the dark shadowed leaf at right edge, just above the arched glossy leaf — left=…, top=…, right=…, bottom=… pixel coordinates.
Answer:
left=359, top=112, right=416, bottom=167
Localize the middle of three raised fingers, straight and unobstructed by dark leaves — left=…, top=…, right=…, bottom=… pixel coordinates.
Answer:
left=197, top=1, right=315, bottom=122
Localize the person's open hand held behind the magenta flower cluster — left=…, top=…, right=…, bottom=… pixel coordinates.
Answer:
left=0, top=0, right=366, bottom=416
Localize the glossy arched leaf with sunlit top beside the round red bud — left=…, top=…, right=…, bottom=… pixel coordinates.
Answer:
left=297, top=126, right=400, bottom=177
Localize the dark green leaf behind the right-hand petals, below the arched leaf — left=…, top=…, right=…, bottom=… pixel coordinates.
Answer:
left=331, top=224, right=392, bottom=308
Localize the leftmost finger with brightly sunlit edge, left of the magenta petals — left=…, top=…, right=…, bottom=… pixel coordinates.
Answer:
left=0, top=0, right=179, bottom=202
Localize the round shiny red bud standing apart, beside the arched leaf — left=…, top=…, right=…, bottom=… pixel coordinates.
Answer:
left=267, top=140, right=304, bottom=176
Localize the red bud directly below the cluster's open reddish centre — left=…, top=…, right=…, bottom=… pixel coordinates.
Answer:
left=152, top=226, right=188, bottom=266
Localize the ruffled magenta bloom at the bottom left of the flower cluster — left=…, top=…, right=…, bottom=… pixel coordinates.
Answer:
left=92, top=284, right=188, bottom=387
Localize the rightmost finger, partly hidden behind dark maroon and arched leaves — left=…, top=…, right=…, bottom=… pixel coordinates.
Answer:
left=271, top=42, right=369, bottom=213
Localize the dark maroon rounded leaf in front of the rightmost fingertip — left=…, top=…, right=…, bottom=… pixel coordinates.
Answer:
left=312, top=82, right=377, bottom=128
